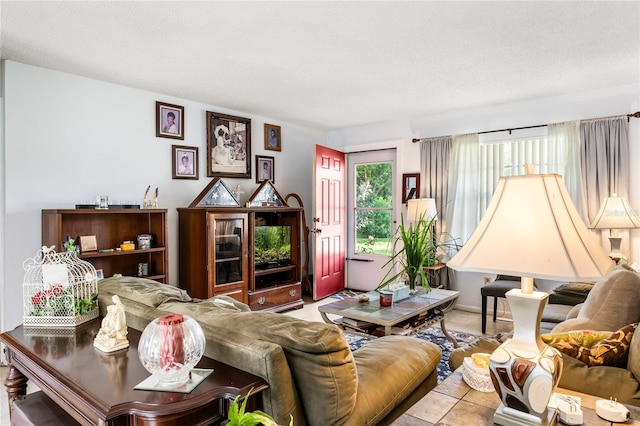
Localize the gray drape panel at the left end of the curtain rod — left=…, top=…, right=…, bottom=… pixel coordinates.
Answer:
left=420, top=136, right=453, bottom=233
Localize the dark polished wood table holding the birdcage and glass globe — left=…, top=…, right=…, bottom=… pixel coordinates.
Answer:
left=0, top=319, right=268, bottom=426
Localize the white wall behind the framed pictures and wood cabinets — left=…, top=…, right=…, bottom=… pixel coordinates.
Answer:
left=0, top=61, right=325, bottom=330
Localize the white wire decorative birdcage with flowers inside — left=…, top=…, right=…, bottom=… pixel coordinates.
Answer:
left=22, top=246, right=98, bottom=327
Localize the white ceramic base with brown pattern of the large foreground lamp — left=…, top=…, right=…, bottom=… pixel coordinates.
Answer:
left=489, top=290, right=562, bottom=426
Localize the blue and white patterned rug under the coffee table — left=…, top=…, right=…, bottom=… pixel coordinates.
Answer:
left=344, top=326, right=478, bottom=383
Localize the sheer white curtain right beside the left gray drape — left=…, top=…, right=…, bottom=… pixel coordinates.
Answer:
left=443, top=133, right=481, bottom=257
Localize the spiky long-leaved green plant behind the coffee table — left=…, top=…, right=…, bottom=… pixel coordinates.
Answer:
left=378, top=210, right=457, bottom=292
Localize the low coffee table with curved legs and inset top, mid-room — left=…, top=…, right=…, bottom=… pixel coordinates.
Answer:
left=318, top=289, right=460, bottom=348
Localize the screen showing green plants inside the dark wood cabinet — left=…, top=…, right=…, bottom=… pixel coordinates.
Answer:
left=254, top=225, right=291, bottom=269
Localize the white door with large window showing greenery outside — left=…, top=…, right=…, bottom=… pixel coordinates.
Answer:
left=347, top=149, right=397, bottom=291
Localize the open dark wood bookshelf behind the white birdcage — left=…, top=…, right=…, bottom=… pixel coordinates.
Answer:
left=42, top=209, right=169, bottom=283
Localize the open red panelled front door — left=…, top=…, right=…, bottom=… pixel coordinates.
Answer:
left=312, top=145, right=346, bottom=300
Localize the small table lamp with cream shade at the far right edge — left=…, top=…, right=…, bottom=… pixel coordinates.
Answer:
left=589, top=194, right=640, bottom=260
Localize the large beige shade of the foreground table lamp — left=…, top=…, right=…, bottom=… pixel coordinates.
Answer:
left=447, top=174, right=614, bottom=281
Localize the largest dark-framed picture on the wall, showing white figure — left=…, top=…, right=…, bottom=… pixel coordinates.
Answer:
left=207, top=111, right=251, bottom=179
